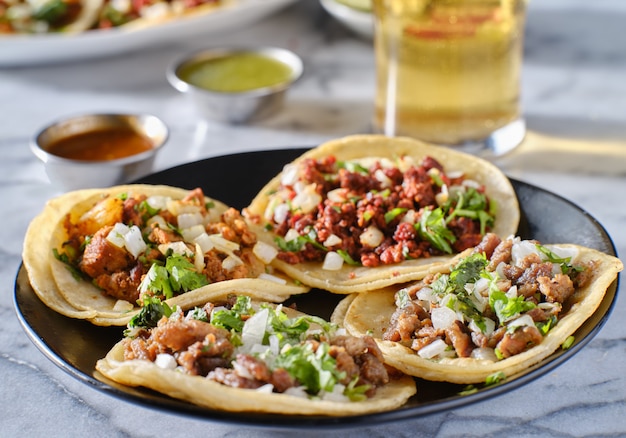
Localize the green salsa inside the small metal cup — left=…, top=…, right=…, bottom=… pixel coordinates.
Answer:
left=179, top=52, right=293, bottom=92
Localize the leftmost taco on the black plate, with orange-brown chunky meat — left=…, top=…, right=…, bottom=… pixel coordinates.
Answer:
left=24, top=185, right=308, bottom=325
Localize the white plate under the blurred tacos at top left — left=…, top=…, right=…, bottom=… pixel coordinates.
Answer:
left=0, top=0, right=296, bottom=67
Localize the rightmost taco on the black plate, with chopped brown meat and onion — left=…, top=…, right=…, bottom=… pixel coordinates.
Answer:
left=334, top=234, right=623, bottom=383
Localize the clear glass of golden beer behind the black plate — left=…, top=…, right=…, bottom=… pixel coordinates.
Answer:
left=373, top=0, right=526, bottom=155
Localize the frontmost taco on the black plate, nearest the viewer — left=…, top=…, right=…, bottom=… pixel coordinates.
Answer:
left=96, top=295, right=416, bottom=416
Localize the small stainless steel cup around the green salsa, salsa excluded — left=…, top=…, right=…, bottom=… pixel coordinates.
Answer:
left=167, top=47, right=303, bottom=124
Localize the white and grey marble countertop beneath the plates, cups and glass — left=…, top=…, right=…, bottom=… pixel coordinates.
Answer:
left=0, top=0, right=626, bottom=437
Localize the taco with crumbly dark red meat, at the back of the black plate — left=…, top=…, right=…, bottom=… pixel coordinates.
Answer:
left=244, top=135, right=520, bottom=294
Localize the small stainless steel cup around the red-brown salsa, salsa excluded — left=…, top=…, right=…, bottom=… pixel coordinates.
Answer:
left=30, top=114, right=169, bottom=190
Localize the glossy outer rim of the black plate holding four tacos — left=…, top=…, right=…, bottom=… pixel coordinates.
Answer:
left=13, top=148, right=620, bottom=430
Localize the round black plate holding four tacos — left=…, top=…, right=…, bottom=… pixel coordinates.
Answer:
left=15, top=149, right=619, bottom=430
